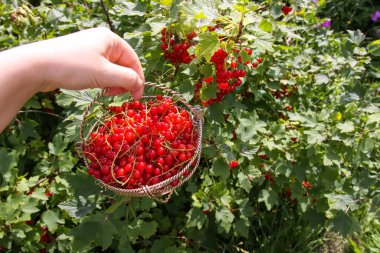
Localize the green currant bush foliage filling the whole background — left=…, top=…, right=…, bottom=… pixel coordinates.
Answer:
left=0, top=0, right=380, bottom=252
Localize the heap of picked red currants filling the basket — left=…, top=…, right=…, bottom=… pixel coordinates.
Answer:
left=84, top=95, right=197, bottom=189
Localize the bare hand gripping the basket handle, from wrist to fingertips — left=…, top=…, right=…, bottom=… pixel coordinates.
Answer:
left=35, top=28, right=144, bottom=99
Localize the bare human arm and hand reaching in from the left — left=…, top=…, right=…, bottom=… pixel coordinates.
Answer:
left=0, top=28, right=144, bottom=132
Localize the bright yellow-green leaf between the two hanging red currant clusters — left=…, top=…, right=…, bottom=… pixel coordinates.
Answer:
left=195, top=32, right=220, bottom=62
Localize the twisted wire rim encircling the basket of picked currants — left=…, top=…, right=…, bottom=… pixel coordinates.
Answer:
left=80, top=82, right=204, bottom=203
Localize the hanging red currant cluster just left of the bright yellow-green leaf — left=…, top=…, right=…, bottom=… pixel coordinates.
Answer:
left=161, top=28, right=197, bottom=65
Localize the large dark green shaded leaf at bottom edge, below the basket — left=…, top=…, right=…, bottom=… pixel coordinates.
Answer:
left=70, top=214, right=117, bottom=252
